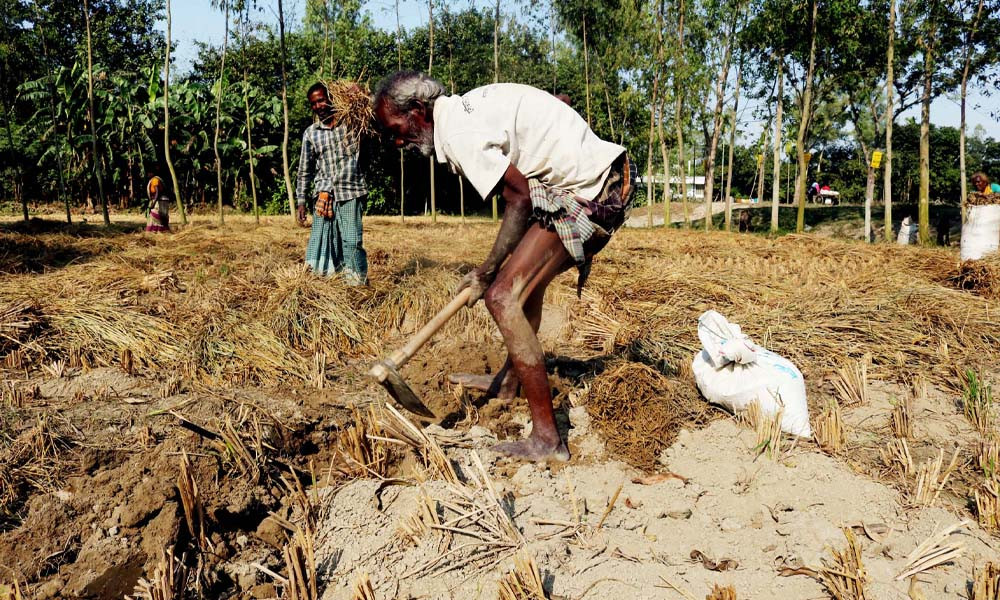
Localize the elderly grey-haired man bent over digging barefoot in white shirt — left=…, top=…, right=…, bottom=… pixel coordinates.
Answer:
left=375, top=71, right=635, bottom=460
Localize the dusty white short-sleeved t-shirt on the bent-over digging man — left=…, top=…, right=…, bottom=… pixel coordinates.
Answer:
left=434, top=83, right=625, bottom=200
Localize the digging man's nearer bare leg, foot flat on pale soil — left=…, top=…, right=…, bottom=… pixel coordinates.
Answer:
left=485, top=226, right=572, bottom=460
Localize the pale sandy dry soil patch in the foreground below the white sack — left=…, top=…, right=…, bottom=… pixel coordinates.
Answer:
left=306, top=408, right=997, bottom=600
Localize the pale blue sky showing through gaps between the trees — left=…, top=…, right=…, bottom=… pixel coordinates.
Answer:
left=157, top=0, right=1000, bottom=140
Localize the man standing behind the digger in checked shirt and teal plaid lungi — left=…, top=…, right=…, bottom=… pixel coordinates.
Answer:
left=295, top=83, right=368, bottom=285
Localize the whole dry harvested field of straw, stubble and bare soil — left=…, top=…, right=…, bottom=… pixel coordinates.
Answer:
left=0, top=218, right=1000, bottom=600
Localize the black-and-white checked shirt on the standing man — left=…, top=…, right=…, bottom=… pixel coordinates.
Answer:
left=295, top=122, right=368, bottom=205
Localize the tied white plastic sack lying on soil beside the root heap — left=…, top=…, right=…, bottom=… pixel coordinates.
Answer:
left=691, top=310, right=812, bottom=437
